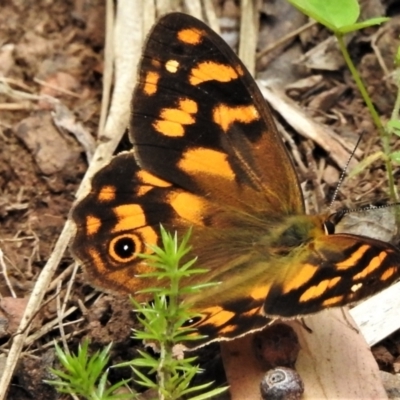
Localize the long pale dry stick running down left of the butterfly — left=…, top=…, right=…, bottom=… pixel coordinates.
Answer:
left=0, top=0, right=144, bottom=400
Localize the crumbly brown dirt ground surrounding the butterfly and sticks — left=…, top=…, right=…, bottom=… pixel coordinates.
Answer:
left=0, top=0, right=400, bottom=400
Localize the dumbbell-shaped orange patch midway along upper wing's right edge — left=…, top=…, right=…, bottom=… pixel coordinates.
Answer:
left=213, top=104, right=260, bottom=132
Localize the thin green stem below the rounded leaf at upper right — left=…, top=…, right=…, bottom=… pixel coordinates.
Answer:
left=335, top=32, right=398, bottom=202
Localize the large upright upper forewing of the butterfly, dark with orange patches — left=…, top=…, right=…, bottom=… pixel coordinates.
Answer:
left=131, top=13, right=303, bottom=214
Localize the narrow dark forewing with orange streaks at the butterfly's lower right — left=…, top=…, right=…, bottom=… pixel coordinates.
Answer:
left=263, top=234, right=400, bottom=318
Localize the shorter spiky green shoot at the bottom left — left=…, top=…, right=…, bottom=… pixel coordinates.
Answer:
left=45, top=340, right=133, bottom=400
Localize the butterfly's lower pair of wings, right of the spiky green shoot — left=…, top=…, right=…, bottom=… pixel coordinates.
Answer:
left=183, top=228, right=400, bottom=347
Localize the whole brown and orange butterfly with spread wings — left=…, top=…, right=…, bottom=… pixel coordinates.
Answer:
left=72, top=13, right=400, bottom=344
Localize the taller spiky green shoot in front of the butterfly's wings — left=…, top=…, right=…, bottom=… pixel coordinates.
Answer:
left=124, top=227, right=226, bottom=400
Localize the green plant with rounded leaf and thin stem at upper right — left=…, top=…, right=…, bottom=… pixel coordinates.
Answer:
left=288, top=0, right=400, bottom=202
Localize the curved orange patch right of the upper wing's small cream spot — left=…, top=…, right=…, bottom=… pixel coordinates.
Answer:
left=189, top=61, right=243, bottom=86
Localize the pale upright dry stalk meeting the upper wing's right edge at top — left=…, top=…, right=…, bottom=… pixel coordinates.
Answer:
left=238, top=0, right=258, bottom=76
